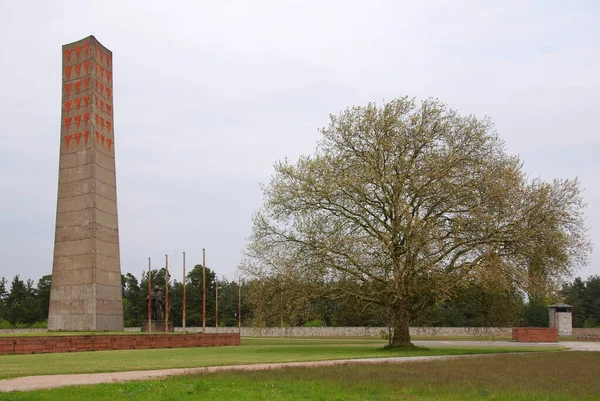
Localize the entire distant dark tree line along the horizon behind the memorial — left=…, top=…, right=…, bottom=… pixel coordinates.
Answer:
left=0, top=272, right=600, bottom=329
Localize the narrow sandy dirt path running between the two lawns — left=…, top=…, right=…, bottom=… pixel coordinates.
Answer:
left=0, top=354, right=493, bottom=392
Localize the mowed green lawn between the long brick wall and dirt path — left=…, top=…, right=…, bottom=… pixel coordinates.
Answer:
left=0, top=339, right=557, bottom=379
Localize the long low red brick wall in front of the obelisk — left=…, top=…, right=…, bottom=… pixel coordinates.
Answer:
left=0, top=333, right=240, bottom=355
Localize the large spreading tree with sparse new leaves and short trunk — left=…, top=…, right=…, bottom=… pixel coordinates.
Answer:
left=241, top=98, right=588, bottom=346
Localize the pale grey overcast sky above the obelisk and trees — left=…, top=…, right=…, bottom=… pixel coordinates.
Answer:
left=0, top=0, right=600, bottom=288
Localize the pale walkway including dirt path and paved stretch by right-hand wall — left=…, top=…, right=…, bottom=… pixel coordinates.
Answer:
left=0, top=341, right=600, bottom=392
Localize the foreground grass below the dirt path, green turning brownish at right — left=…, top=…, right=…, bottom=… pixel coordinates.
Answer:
left=0, top=351, right=600, bottom=401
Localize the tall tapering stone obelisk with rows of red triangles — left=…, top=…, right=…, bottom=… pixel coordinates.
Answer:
left=48, top=36, right=123, bottom=331
